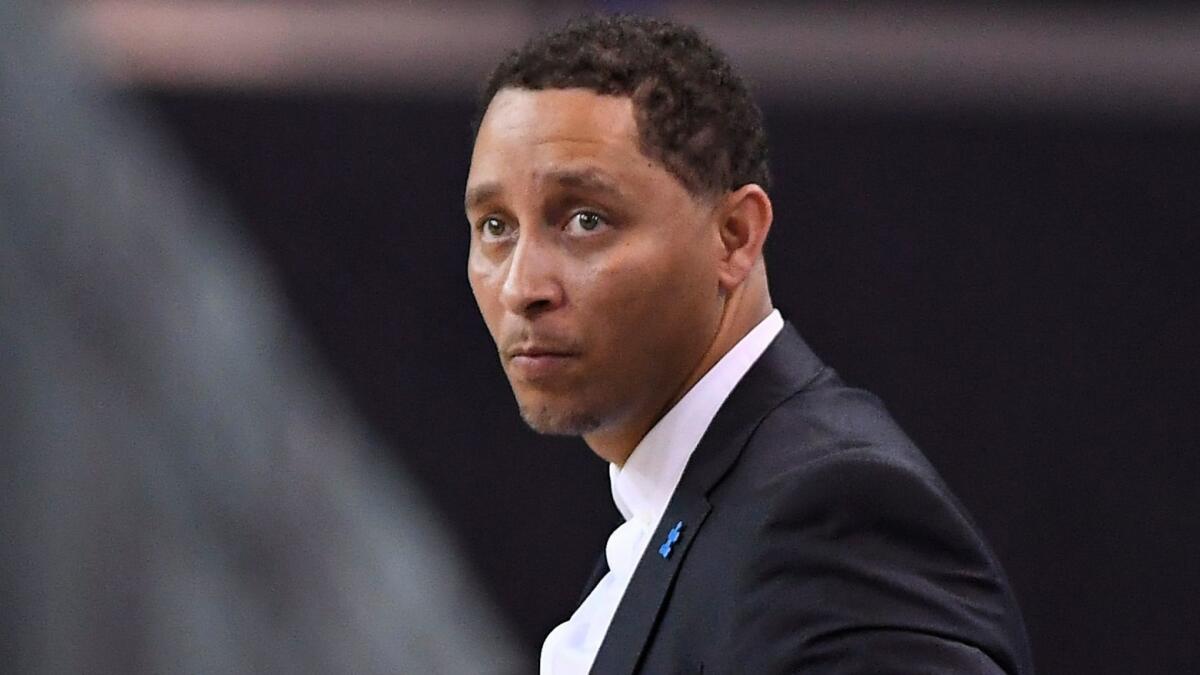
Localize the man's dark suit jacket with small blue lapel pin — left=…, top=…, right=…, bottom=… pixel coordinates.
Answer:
left=588, top=324, right=1033, bottom=675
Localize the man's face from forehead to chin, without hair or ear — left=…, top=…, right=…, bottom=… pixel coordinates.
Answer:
left=467, top=89, right=721, bottom=435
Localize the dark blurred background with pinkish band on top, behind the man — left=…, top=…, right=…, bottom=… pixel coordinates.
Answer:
left=58, top=1, right=1200, bottom=674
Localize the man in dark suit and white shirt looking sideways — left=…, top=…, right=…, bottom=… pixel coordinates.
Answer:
left=466, top=11, right=1032, bottom=674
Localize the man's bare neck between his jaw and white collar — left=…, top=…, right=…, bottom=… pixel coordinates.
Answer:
left=583, top=270, right=773, bottom=466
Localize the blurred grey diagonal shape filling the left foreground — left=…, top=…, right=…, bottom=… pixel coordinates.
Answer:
left=0, top=2, right=524, bottom=673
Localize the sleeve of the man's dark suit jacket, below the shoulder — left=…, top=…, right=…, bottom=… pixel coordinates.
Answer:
left=732, top=448, right=1031, bottom=675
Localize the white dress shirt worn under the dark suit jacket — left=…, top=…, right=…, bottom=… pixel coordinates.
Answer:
left=541, top=310, right=784, bottom=675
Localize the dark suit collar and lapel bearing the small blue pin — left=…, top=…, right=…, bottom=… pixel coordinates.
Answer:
left=589, top=323, right=822, bottom=675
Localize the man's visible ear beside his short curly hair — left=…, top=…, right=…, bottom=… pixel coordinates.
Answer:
left=718, top=183, right=774, bottom=291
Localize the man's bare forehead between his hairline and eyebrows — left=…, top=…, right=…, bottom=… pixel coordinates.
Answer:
left=468, top=89, right=646, bottom=185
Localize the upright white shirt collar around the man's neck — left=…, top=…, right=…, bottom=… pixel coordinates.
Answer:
left=608, top=310, right=784, bottom=525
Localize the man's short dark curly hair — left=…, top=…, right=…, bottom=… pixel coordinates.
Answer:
left=474, top=14, right=770, bottom=195
